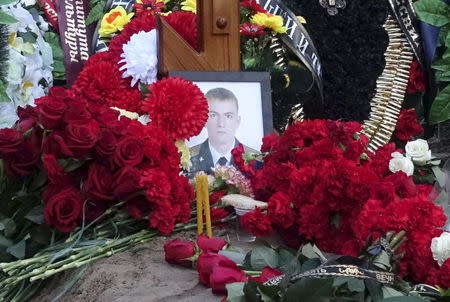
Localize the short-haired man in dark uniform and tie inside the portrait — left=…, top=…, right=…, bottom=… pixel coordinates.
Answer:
left=189, top=87, right=258, bottom=176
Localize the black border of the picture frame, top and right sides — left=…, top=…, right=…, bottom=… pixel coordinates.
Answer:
left=168, top=70, right=274, bottom=136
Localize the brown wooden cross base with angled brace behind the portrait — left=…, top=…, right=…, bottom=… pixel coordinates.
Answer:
left=159, top=0, right=241, bottom=73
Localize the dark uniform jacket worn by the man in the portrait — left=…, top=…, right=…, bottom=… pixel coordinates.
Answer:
left=188, top=139, right=259, bottom=177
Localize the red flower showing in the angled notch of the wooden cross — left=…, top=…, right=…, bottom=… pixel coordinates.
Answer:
left=163, top=11, right=200, bottom=50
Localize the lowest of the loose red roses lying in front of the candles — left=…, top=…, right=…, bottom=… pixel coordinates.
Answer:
left=209, top=263, right=247, bottom=294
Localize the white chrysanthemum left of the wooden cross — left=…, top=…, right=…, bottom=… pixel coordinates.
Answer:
left=119, top=29, right=158, bottom=86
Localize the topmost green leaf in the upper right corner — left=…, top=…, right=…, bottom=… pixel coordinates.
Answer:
left=413, top=0, right=450, bottom=27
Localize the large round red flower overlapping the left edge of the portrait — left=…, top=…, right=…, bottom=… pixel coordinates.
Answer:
left=142, top=77, right=208, bottom=140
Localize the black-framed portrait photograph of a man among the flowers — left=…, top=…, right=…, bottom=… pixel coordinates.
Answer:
left=169, top=71, right=273, bottom=175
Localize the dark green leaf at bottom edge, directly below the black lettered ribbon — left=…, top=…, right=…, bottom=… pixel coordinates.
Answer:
left=286, top=278, right=334, bottom=302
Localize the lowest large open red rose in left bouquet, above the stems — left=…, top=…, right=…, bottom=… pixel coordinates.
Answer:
left=44, top=187, right=85, bottom=232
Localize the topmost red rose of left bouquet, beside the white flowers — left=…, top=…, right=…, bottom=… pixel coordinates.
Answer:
left=35, top=96, right=66, bottom=129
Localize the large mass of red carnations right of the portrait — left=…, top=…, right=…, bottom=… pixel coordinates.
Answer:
left=235, top=120, right=450, bottom=287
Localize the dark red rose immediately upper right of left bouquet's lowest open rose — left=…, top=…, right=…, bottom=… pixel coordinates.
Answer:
left=83, top=163, right=116, bottom=200
